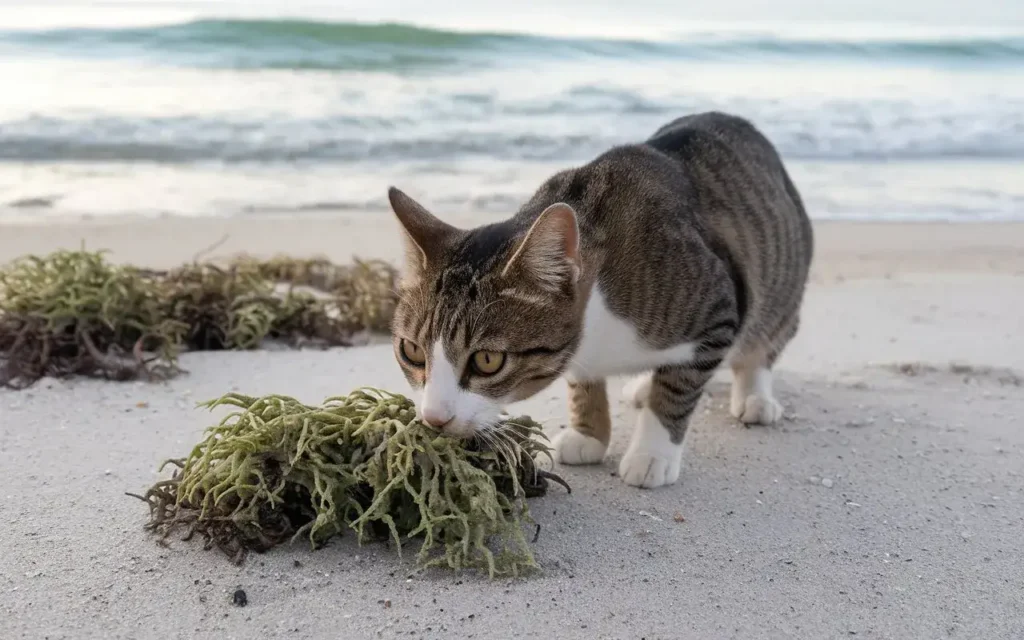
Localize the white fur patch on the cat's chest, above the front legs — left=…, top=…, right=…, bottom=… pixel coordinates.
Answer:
left=565, top=287, right=695, bottom=380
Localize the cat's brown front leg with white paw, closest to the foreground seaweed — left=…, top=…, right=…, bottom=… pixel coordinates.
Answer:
left=552, top=380, right=611, bottom=465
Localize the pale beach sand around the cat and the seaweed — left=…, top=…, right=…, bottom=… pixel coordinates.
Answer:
left=0, top=214, right=1024, bottom=639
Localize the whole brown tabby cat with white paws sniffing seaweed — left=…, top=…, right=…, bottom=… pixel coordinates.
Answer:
left=388, top=112, right=814, bottom=488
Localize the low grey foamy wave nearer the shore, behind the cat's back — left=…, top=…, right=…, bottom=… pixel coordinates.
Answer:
left=0, top=111, right=1024, bottom=166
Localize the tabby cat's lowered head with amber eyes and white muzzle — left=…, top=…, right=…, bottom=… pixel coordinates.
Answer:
left=388, top=187, right=582, bottom=437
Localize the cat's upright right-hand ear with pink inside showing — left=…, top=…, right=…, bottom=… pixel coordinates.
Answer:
left=502, top=203, right=582, bottom=291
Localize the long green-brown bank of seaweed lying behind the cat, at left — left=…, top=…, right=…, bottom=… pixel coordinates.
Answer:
left=0, top=250, right=397, bottom=388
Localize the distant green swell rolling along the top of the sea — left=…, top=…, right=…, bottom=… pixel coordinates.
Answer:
left=0, top=19, right=1024, bottom=72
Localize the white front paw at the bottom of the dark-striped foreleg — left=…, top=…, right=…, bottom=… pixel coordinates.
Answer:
left=618, top=409, right=683, bottom=488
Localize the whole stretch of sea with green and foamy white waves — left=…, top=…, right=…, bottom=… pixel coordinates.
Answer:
left=0, top=0, right=1024, bottom=221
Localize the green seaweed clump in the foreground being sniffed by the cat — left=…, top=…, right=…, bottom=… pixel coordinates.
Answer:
left=132, top=388, right=567, bottom=577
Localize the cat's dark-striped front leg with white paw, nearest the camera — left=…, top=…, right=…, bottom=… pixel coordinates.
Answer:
left=618, top=364, right=715, bottom=488
